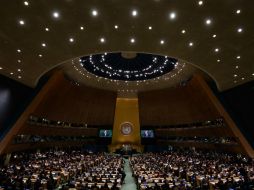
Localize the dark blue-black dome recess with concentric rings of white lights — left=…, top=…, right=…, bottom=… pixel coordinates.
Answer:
left=79, top=53, right=178, bottom=81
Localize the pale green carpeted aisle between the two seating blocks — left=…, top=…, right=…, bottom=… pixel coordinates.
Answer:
left=121, top=158, right=137, bottom=190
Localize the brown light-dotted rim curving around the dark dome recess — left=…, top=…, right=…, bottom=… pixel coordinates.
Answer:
left=61, top=51, right=197, bottom=94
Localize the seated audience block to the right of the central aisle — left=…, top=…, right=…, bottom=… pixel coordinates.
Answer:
left=130, top=150, right=254, bottom=190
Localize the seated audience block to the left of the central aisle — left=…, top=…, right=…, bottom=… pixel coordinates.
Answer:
left=0, top=151, right=124, bottom=190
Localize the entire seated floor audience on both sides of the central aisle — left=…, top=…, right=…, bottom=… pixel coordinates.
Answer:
left=0, top=149, right=254, bottom=190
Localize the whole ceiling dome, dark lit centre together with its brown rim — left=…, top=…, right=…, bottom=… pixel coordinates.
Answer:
left=60, top=52, right=196, bottom=93
